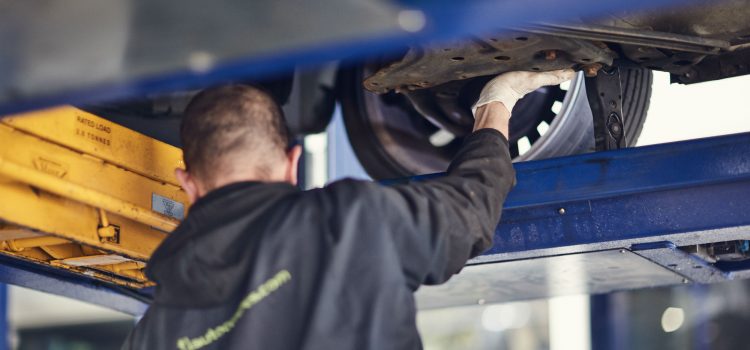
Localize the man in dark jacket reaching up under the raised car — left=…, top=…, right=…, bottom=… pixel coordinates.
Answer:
left=123, top=70, right=574, bottom=350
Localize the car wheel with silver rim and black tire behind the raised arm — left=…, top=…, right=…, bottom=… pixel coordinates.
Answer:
left=337, top=66, right=653, bottom=179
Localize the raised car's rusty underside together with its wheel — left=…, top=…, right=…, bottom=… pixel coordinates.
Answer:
left=340, top=1, right=750, bottom=178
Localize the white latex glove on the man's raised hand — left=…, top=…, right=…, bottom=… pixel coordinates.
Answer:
left=471, top=69, right=576, bottom=115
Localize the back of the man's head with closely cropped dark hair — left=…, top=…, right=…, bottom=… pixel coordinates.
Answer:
left=180, top=85, right=289, bottom=184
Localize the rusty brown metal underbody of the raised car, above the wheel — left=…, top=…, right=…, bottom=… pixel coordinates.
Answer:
left=364, top=0, right=750, bottom=94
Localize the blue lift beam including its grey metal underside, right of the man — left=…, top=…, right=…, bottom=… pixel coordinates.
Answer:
left=412, top=134, right=750, bottom=308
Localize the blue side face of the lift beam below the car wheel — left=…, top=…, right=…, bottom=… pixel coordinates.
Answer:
left=400, top=134, right=750, bottom=263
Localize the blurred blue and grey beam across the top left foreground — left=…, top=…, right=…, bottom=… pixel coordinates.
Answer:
left=0, top=0, right=692, bottom=114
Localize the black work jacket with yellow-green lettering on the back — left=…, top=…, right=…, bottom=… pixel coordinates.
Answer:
left=123, top=129, right=515, bottom=350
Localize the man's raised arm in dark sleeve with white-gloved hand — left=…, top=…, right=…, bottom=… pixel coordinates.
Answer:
left=380, top=70, right=575, bottom=289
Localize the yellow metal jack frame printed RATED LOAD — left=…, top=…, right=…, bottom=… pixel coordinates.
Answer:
left=0, top=107, right=188, bottom=288
